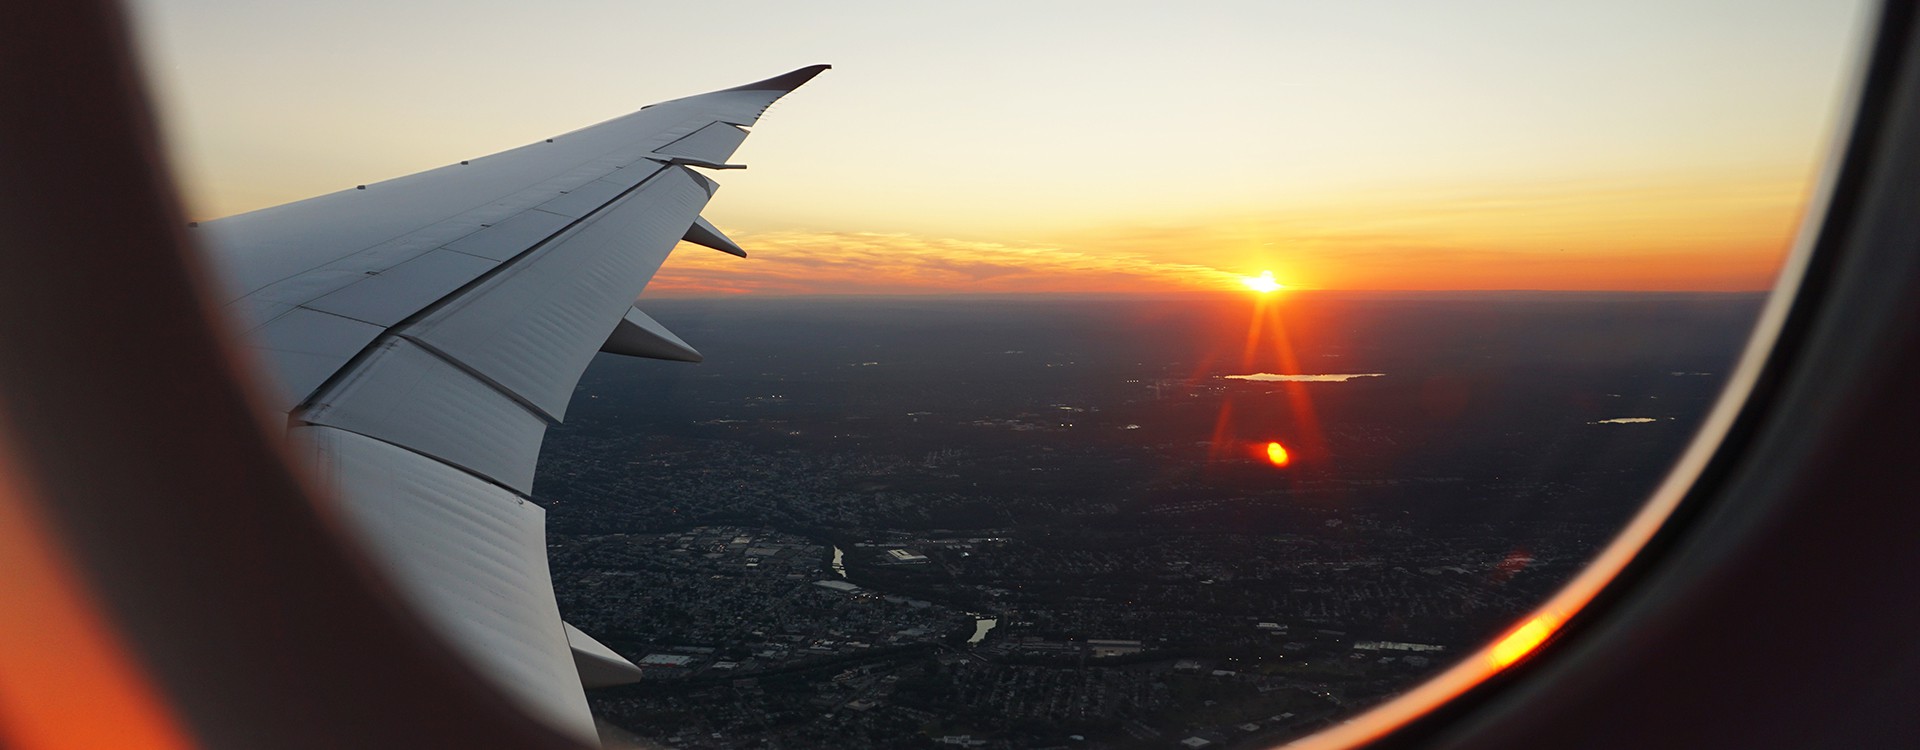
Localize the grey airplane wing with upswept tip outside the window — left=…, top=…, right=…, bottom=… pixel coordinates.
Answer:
left=192, top=65, right=828, bottom=742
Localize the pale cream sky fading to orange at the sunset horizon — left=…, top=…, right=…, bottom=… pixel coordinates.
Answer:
left=131, top=0, right=1868, bottom=295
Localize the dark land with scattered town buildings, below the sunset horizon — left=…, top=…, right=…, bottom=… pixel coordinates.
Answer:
left=536, top=293, right=1761, bottom=748
